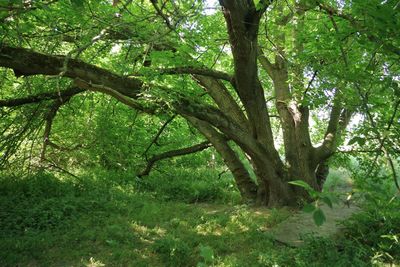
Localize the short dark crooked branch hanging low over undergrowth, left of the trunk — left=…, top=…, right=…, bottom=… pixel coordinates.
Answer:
left=137, top=141, right=211, bottom=177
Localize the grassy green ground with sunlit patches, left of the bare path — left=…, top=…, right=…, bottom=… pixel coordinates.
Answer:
left=0, top=171, right=394, bottom=266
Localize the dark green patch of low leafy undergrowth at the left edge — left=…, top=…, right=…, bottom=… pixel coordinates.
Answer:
left=0, top=172, right=121, bottom=236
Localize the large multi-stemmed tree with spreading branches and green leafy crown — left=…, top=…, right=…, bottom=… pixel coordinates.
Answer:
left=0, top=0, right=400, bottom=207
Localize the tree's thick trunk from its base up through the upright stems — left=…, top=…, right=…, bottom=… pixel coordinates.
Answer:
left=216, top=0, right=317, bottom=206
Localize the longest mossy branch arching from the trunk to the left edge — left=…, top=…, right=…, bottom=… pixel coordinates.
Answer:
left=0, top=45, right=273, bottom=166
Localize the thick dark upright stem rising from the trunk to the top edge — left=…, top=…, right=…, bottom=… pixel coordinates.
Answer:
left=220, top=0, right=278, bottom=158
